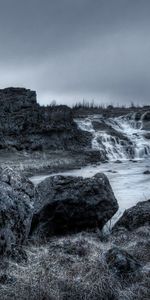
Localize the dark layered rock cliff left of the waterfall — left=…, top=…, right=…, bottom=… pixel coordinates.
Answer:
left=0, top=88, right=90, bottom=150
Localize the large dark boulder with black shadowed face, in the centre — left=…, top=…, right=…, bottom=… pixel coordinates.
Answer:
left=31, top=174, right=118, bottom=239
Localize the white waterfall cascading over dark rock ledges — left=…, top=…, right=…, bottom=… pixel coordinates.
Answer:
left=75, top=113, right=150, bottom=160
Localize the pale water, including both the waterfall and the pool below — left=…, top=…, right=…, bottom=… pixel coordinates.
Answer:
left=30, top=114, right=150, bottom=221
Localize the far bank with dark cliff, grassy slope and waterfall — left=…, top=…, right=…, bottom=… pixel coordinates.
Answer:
left=0, top=88, right=150, bottom=175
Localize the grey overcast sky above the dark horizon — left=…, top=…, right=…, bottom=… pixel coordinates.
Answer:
left=0, top=0, right=150, bottom=105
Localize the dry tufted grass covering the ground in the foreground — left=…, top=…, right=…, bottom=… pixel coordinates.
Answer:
left=0, top=228, right=150, bottom=300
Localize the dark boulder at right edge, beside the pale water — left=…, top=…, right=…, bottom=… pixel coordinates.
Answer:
left=113, top=200, right=150, bottom=231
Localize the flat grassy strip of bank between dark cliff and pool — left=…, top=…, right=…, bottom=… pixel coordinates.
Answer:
left=0, top=149, right=103, bottom=176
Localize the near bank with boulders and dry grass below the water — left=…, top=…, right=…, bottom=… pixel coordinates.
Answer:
left=0, top=168, right=150, bottom=300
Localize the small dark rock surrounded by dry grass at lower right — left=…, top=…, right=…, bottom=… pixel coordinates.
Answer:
left=106, top=247, right=141, bottom=275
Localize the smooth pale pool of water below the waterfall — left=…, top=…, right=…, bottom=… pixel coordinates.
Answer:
left=30, top=159, right=150, bottom=221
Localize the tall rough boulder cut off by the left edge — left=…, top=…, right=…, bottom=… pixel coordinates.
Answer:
left=0, top=168, right=34, bottom=256
